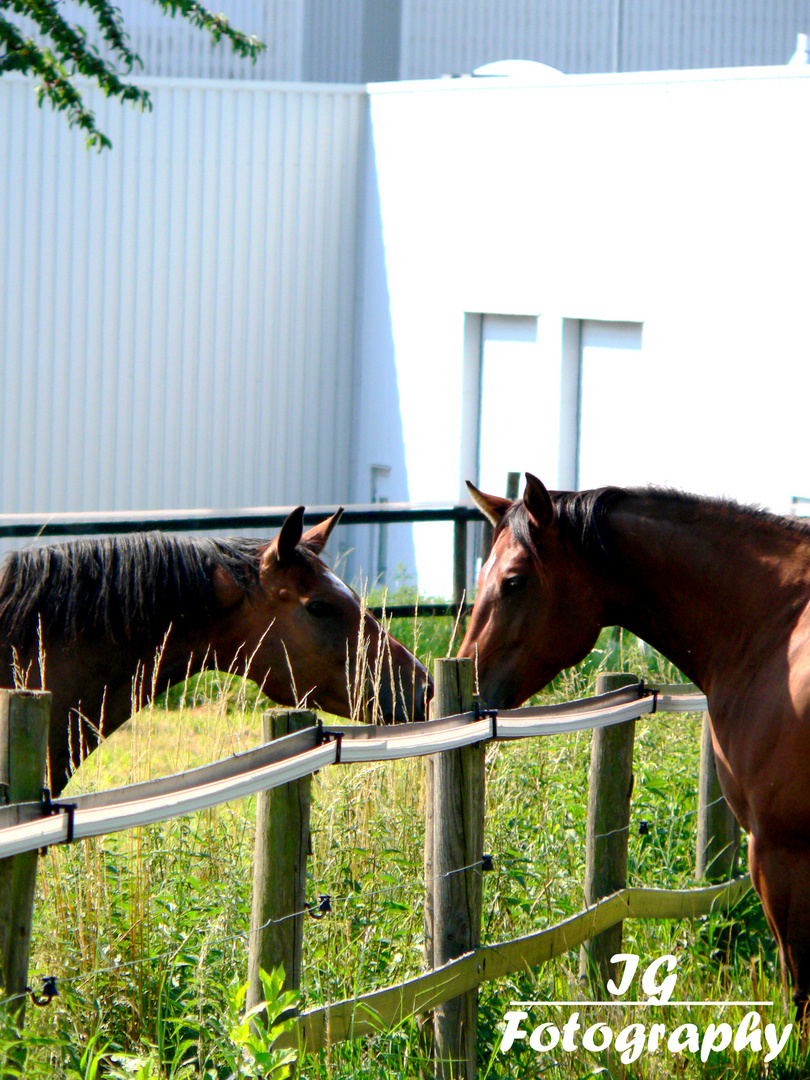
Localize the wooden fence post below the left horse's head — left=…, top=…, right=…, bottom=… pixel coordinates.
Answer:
left=246, top=708, right=316, bottom=1009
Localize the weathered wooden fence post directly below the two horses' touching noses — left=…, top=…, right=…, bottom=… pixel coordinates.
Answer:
left=424, top=659, right=485, bottom=1080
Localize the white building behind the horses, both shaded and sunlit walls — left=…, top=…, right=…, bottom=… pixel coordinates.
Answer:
left=0, top=67, right=810, bottom=594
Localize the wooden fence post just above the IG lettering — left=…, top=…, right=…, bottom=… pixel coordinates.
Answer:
left=579, top=672, right=638, bottom=997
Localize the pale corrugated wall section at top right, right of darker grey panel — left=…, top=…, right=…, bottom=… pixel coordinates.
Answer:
left=400, top=0, right=810, bottom=79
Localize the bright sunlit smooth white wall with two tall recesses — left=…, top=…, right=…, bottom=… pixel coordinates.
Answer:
left=357, top=68, right=810, bottom=592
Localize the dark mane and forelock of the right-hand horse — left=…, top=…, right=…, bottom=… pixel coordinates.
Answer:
left=496, top=487, right=810, bottom=562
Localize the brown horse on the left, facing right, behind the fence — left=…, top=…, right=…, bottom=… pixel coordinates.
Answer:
left=0, top=507, right=430, bottom=793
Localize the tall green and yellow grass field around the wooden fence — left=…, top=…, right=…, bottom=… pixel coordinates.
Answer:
left=0, top=619, right=810, bottom=1080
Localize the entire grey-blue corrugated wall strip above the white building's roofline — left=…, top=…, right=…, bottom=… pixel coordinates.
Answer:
left=14, top=0, right=810, bottom=82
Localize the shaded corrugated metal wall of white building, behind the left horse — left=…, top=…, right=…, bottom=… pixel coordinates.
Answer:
left=0, top=77, right=365, bottom=513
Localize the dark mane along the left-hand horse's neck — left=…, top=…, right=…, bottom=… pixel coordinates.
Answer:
left=0, top=532, right=273, bottom=650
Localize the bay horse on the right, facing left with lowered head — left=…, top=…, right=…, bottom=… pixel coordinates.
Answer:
left=459, top=473, right=810, bottom=1022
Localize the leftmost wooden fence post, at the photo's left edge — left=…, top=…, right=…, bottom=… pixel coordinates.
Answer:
left=0, top=690, right=51, bottom=1031
